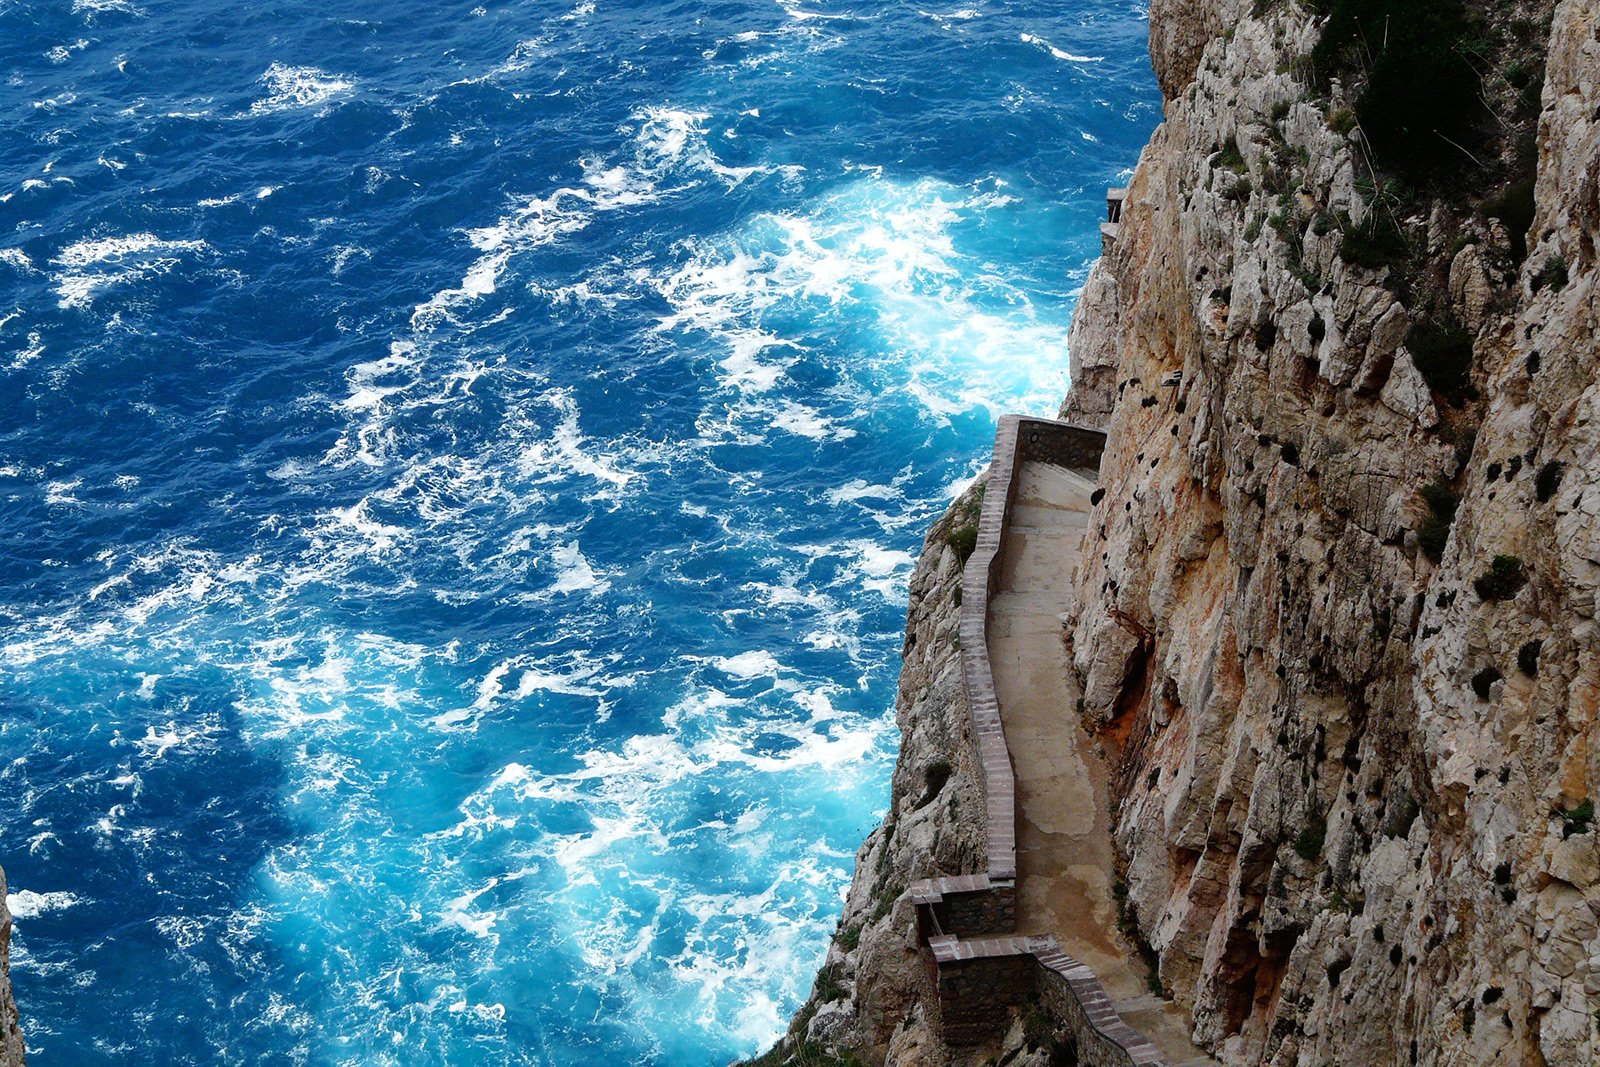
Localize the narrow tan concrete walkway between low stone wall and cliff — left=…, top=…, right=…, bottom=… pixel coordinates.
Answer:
left=989, top=462, right=1214, bottom=1067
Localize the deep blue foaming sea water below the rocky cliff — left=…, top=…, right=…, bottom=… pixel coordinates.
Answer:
left=0, top=0, right=1158, bottom=1067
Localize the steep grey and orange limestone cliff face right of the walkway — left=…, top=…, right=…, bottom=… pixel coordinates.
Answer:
left=1064, top=0, right=1600, bottom=1064
